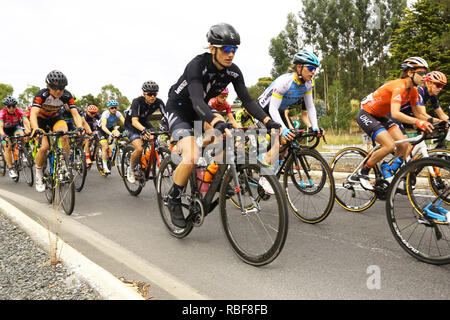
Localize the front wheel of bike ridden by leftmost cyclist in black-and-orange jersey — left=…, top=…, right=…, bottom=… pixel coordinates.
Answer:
left=55, top=150, right=75, bottom=215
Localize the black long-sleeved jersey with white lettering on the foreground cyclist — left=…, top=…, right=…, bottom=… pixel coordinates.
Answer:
left=164, top=53, right=267, bottom=132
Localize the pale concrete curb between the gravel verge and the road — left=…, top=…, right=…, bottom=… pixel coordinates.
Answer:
left=0, top=198, right=145, bottom=300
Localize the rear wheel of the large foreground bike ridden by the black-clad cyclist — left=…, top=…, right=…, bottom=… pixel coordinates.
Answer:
left=156, top=157, right=194, bottom=238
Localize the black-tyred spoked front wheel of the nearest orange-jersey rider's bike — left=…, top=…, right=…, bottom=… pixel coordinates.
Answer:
left=386, top=157, right=450, bottom=265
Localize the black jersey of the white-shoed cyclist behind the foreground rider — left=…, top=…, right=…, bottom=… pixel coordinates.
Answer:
left=125, top=96, right=164, bottom=130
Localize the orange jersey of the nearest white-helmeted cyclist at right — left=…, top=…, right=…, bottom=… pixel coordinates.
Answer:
left=361, top=79, right=419, bottom=117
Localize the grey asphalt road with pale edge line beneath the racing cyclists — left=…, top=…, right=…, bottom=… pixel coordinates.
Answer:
left=0, top=168, right=450, bottom=300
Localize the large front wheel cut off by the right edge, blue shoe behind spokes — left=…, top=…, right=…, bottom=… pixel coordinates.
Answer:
left=386, top=158, right=450, bottom=265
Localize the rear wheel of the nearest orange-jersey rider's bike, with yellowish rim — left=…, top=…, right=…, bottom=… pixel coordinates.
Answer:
left=330, top=147, right=377, bottom=212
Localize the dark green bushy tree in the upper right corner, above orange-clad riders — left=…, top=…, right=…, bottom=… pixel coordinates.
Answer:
left=390, top=0, right=450, bottom=106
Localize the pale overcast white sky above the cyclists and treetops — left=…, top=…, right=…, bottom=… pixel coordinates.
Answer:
left=0, top=0, right=301, bottom=102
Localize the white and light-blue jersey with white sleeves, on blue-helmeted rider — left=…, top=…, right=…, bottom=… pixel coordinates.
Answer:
left=258, top=73, right=318, bottom=129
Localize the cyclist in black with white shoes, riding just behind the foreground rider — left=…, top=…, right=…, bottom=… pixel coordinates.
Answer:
left=125, top=81, right=164, bottom=183
